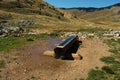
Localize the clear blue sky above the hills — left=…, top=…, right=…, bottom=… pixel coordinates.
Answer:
left=44, top=0, right=120, bottom=8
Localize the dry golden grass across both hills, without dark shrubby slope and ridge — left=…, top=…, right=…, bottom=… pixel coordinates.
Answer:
left=0, top=1, right=120, bottom=32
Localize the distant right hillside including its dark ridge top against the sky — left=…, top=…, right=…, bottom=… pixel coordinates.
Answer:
left=64, top=3, right=120, bottom=28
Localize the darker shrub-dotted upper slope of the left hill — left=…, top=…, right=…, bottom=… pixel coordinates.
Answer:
left=0, top=0, right=64, bottom=18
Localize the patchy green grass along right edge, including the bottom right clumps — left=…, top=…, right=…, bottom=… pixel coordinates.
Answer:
left=87, top=39, right=120, bottom=80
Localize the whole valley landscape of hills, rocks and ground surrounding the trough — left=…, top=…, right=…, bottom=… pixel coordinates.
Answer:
left=0, top=0, right=120, bottom=80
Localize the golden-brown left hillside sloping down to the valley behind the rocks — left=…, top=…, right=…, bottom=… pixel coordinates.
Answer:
left=0, top=0, right=93, bottom=33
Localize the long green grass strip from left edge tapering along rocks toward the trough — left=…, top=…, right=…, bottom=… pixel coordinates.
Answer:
left=0, top=33, right=57, bottom=52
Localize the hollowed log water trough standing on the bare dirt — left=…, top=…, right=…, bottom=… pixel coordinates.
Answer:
left=54, top=36, right=82, bottom=60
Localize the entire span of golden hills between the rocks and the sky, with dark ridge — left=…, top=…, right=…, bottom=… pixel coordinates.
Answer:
left=0, top=0, right=120, bottom=33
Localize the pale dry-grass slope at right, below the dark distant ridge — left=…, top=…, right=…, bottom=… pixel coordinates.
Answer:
left=64, top=7, right=120, bottom=29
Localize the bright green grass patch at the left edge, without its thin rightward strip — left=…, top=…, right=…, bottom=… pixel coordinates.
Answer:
left=0, top=37, right=30, bottom=52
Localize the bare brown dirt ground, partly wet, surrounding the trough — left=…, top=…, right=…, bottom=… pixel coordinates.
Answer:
left=0, top=39, right=110, bottom=80
